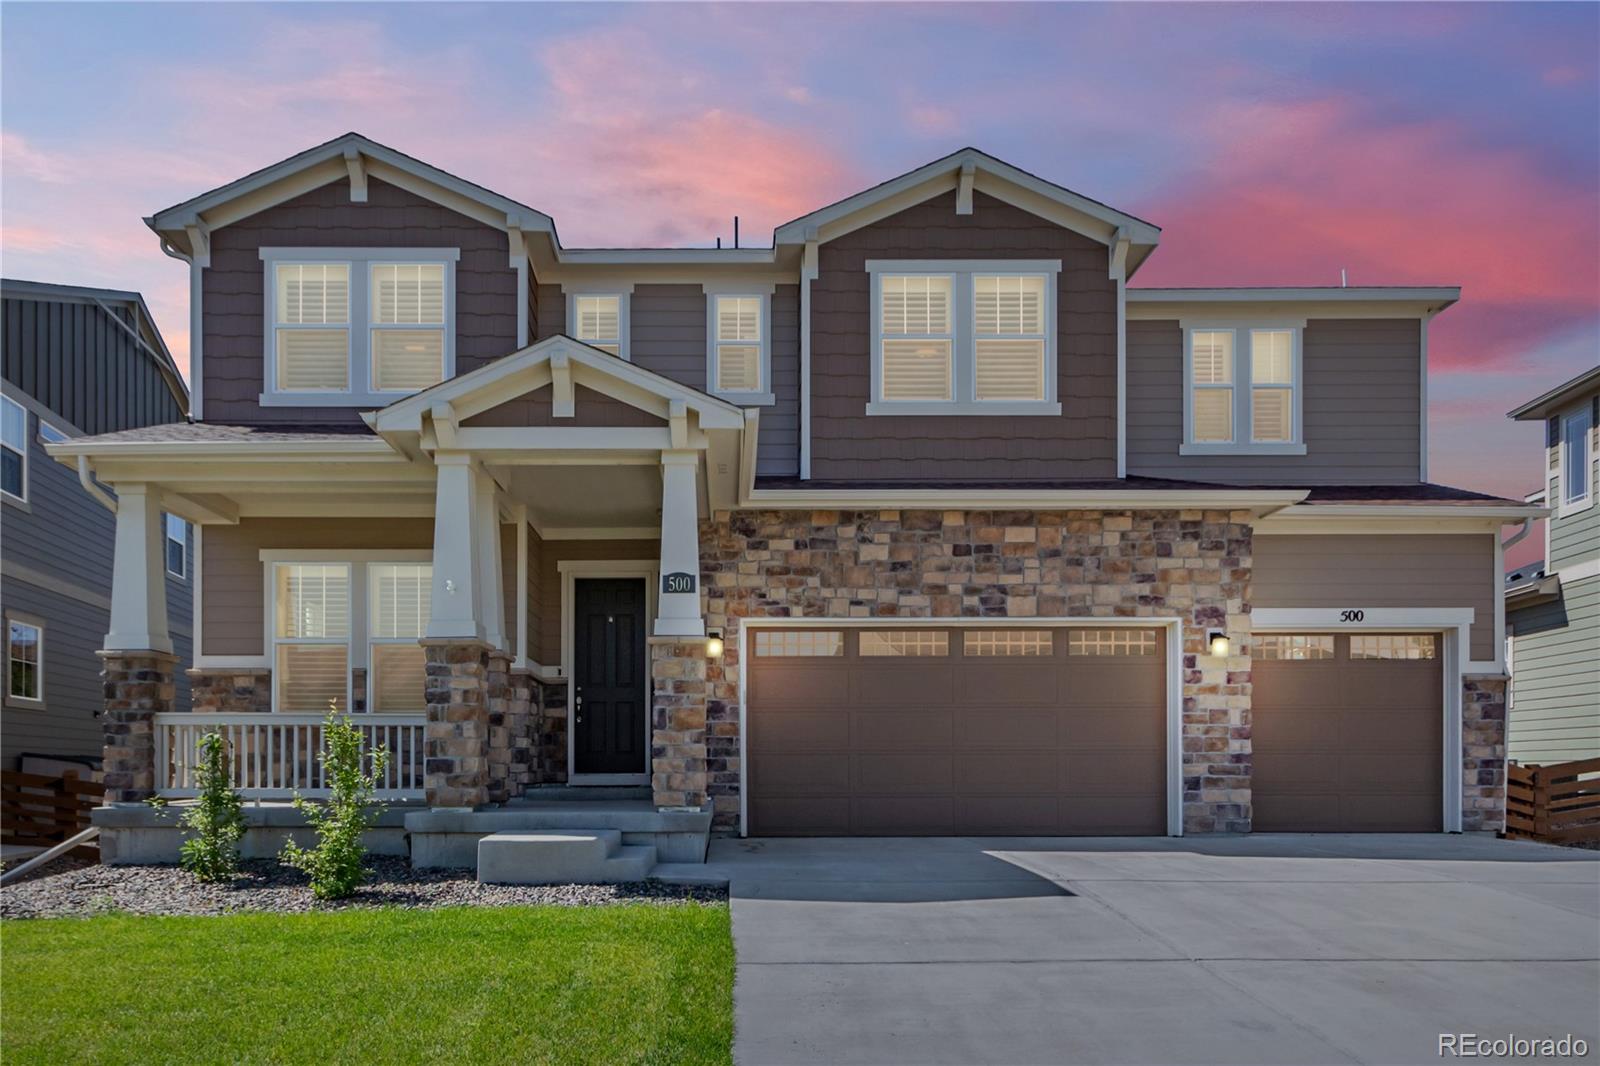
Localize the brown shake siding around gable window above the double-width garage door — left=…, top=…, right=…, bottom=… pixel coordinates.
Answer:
left=811, top=192, right=1117, bottom=480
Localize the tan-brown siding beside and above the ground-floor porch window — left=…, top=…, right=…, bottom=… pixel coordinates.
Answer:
left=197, top=519, right=434, bottom=656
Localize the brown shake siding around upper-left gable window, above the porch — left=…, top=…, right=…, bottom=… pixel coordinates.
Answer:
left=203, top=179, right=517, bottom=424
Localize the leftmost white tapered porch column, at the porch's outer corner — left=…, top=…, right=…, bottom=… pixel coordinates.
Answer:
left=106, top=482, right=173, bottom=651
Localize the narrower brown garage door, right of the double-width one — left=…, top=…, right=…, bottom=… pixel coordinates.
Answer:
left=1251, top=634, right=1443, bottom=832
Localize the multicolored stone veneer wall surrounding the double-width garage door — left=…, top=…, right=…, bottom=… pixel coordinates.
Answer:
left=704, top=511, right=1251, bottom=832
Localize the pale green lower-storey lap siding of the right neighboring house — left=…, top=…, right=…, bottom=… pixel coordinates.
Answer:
left=1506, top=578, right=1600, bottom=763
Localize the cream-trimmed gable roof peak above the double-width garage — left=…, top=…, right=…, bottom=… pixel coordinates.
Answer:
left=773, top=147, right=1162, bottom=275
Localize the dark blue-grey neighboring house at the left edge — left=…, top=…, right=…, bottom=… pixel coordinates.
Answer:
left=0, top=280, right=192, bottom=770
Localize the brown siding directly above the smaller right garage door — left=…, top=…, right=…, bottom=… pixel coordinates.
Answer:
left=1250, top=533, right=1499, bottom=661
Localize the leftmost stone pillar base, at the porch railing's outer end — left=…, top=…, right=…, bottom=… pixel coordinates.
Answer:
left=99, top=651, right=178, bottom=804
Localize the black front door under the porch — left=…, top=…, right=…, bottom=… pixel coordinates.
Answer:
left=573, top=578, right=650, bottom=775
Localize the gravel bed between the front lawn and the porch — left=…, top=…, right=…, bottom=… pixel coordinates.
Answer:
left=0, top=856, right=728, bottom=919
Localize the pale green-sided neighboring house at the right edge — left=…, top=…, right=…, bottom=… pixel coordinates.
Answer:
left=1506, top=367, right=1600, bottom=765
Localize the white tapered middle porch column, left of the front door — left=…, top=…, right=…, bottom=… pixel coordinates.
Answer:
left=427, top=453, right=498, bottom=640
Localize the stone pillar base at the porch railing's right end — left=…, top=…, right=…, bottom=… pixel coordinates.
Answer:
left=422, top=640, right=489, bottom=807
